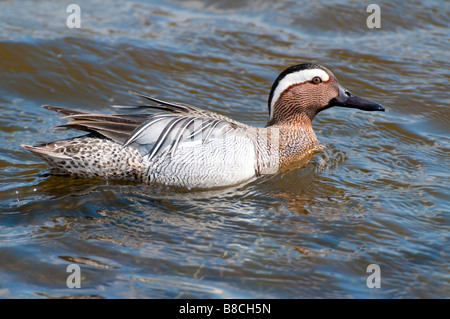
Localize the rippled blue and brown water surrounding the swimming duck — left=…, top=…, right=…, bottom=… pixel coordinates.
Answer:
left=0, top=0, right=450, bottom=298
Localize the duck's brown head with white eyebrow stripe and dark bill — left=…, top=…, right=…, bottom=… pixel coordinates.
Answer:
left=267, top=63, right=384, bottom=126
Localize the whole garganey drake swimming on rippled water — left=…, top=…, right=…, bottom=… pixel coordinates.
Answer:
left=23, top=63, right=384, bottom=189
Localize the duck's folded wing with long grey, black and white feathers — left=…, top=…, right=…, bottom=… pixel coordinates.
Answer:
left=42, top=91, right=247, bottom=160
